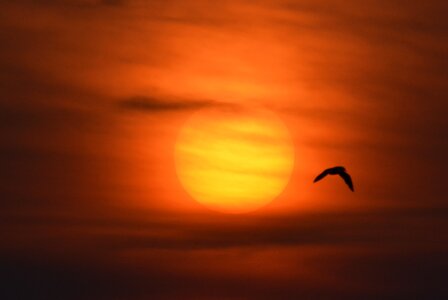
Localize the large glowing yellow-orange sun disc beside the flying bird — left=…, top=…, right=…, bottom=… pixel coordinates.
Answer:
left=175, top=106, right=294, bottom=213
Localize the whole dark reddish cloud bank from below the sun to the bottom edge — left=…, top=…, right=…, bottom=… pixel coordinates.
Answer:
left=0, top=210, right=447, bottom=299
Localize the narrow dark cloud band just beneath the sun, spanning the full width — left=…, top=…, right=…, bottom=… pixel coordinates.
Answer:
left=3, top=209, right=448, bottom=251
